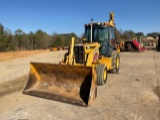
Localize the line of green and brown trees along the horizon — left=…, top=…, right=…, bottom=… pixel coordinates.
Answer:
left=0, top=23, right=160, bottom=52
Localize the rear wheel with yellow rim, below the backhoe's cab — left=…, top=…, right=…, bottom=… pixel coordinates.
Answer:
left=111, top=53, right=120, bottom=73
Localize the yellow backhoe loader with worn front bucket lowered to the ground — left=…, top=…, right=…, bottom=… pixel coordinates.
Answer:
left=23, top=12, right=120, bottom=106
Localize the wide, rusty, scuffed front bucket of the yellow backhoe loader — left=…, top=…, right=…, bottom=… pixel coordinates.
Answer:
left=23, top=62, right=97, bottom=106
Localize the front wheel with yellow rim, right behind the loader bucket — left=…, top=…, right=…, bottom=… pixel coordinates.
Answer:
left=96, top=64, right=107, bottom=85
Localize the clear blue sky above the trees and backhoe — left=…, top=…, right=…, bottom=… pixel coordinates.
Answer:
left=0, top=0, right=160, bottom=36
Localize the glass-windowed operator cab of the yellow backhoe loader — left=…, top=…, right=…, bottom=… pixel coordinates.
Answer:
left=84, top=22, right=115, bottom=57
